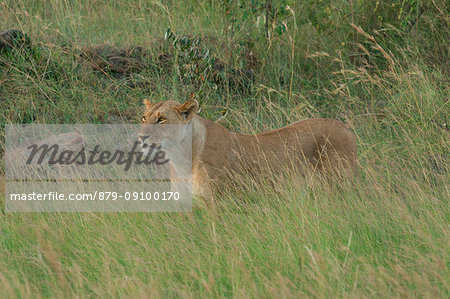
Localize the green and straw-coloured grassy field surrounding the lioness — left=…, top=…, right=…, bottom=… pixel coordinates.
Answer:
left=0, top=0, right=450, bottom=298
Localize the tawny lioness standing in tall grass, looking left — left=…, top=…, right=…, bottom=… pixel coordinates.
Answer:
left=138, top=99, right=356, bottom=196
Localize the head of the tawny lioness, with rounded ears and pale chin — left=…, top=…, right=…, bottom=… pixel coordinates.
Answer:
left=138, top=99, right=198, bottom=152
